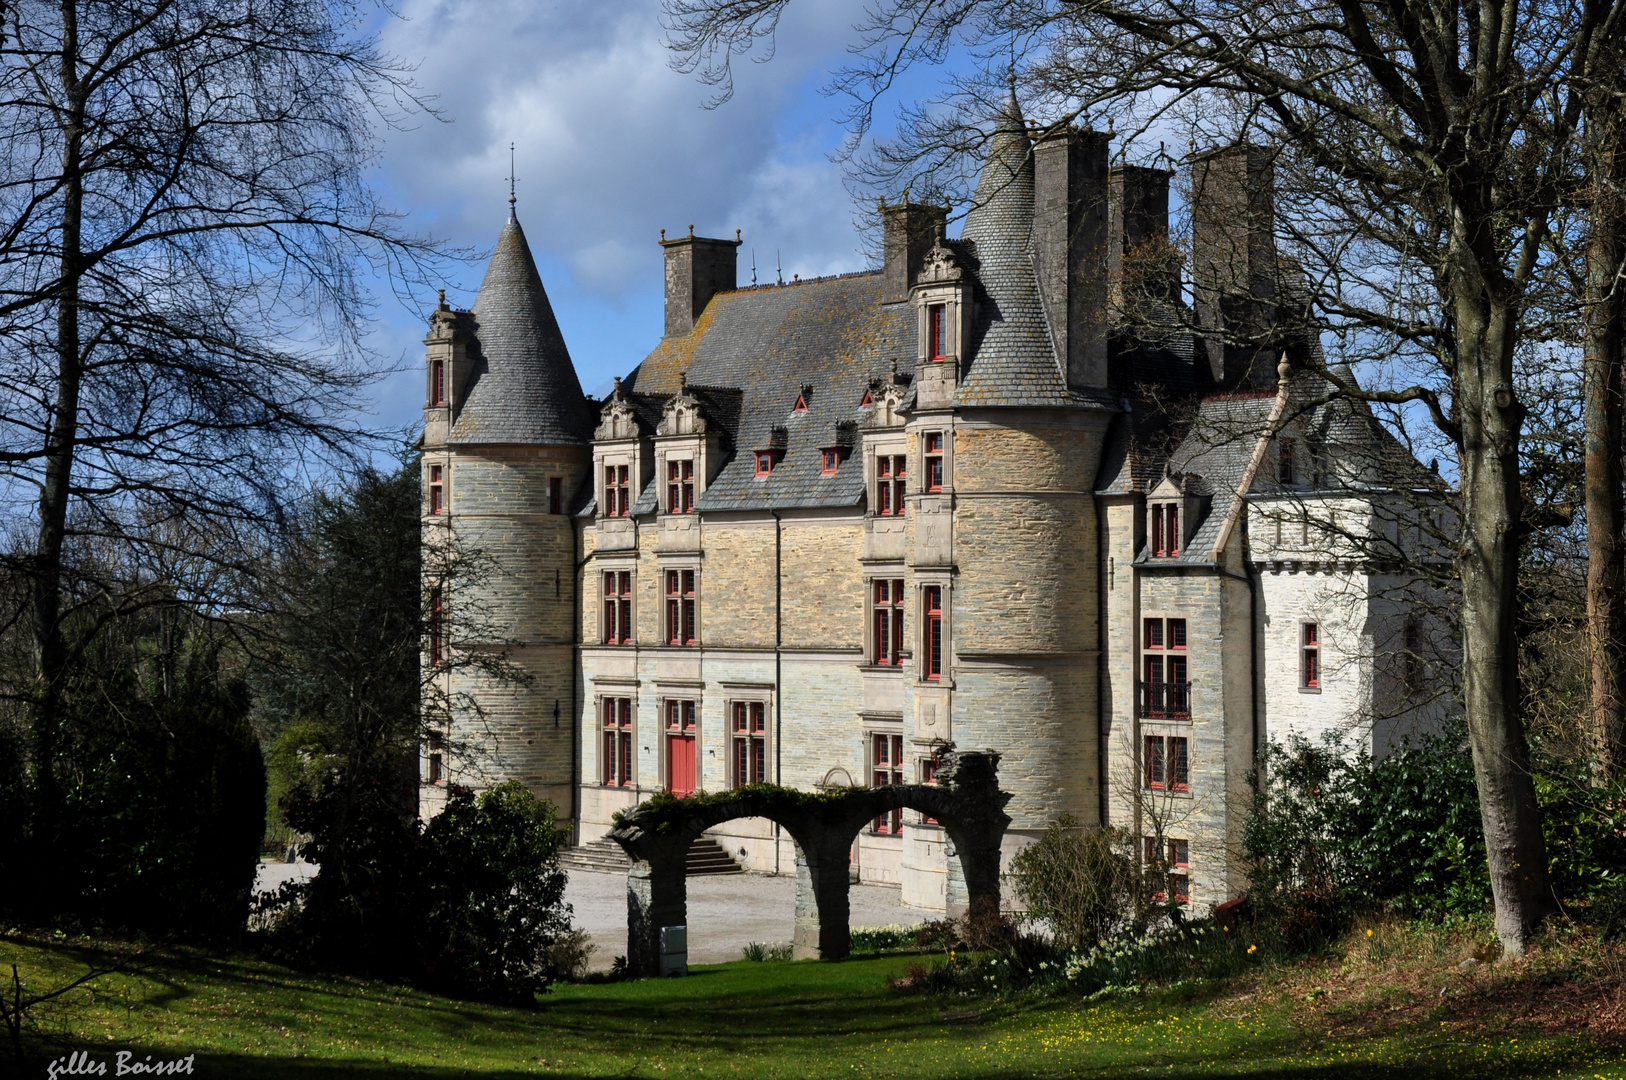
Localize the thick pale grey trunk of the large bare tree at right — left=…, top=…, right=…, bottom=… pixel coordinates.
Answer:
left=1452, top=237, right=1553, bottom=956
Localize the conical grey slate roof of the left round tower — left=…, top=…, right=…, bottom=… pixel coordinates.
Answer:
left=450, top=216, right=592, bottom=446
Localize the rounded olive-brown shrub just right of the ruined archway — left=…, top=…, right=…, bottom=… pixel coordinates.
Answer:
left=1010, top=815, right=1135, bottom=948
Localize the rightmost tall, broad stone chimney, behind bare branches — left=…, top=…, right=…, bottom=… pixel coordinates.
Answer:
left=1192, top=145, right=1276, bottom=389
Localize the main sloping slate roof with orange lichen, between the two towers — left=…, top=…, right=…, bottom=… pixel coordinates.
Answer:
left=624, top=272, right=915, bottom=511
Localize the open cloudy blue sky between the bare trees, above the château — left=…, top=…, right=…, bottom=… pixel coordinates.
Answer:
left=371, top=0, right=891, bottom=428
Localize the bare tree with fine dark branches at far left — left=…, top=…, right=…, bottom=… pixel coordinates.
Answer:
left=0, top=0, right=433, bottom=883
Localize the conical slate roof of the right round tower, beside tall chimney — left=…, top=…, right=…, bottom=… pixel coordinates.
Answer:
left=954, top=94, right=1112, bottom=408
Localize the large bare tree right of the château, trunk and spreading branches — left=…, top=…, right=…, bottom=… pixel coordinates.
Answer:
left=665, top=0, right=1626, bottom=953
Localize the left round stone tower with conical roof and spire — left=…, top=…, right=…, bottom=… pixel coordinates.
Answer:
left=423, top=213, right=592, bottom=818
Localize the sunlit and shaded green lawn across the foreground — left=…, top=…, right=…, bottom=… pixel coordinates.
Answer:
left=0, top=937, right=1626, bottom=1080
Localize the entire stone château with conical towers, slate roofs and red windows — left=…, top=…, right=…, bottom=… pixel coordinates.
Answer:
left=423, top=102, right=1441, bottom=909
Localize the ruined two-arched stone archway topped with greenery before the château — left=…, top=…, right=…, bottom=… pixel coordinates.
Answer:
left=610, top=750, right=1011, bottom=976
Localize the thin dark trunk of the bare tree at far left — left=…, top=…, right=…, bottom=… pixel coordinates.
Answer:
left=31, top=0, right=85, bottom=903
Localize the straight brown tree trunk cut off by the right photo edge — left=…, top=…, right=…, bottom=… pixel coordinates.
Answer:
left=1582, top=76, right=1626, bottom=779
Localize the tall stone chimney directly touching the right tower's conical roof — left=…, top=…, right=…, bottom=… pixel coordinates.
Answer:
left=1033, top=128, right=1109, bottom=390
